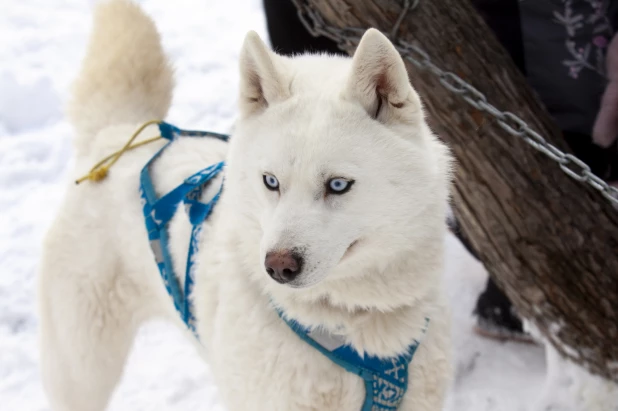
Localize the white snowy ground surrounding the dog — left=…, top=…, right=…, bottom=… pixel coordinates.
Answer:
left=0, top=0, right=545, bottom=411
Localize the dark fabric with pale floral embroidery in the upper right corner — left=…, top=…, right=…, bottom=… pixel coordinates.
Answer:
left=519, top=0, right=617, bottom=135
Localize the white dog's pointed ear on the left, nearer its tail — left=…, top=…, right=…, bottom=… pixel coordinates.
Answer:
left=240, top=31, right=289, bottom=116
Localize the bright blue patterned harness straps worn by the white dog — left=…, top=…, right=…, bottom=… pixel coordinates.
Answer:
left=140, top=122, right=429, bottom=411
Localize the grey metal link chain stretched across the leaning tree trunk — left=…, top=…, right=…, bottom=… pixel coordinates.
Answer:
left=292, top=0, right=618, bottom=209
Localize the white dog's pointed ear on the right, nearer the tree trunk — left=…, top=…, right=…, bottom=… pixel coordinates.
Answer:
left=344, top=29, right=423, bottom=123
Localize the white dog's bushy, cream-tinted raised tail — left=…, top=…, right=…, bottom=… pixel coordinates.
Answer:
left=68, top=0, right=174, bottom=151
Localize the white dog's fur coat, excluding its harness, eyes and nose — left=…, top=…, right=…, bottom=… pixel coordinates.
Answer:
left=39, top=0, right=451, bottom=411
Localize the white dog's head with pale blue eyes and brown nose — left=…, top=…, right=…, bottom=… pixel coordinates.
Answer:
left=226, top=30, right=450, bottom=288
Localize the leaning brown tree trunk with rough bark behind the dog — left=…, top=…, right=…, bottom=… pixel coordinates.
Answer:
left=294, top=0, right=618, bottom=381
